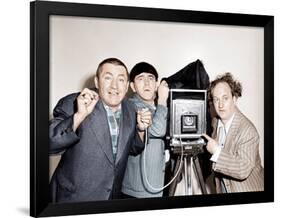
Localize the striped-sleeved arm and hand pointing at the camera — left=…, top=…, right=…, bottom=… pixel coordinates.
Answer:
left=200, top=121, right=259, bottom=180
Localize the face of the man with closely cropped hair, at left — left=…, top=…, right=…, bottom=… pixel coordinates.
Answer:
left=95, top=63, right=129, bottom=111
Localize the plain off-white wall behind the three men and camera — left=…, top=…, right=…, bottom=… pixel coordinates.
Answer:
left=50, top=16, right=264, bottom=165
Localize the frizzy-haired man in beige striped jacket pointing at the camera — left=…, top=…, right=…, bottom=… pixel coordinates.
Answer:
left=203, top=73, right=264, bottom=193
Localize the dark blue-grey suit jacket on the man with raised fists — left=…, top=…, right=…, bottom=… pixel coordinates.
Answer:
left=49, top=94, right=144, bottom=202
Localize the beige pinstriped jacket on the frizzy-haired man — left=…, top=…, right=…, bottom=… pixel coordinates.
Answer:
left=213, top=109, right=264, bottom=192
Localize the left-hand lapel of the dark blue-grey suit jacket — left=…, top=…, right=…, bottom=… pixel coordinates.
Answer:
left=87, top=101, right=114, bottom=164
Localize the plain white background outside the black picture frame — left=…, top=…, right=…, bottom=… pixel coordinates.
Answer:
left=0, top=0, right=281, bottom=218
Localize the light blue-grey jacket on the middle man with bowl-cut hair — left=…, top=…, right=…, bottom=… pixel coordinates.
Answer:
left=122, top=95, right=168, bottom=198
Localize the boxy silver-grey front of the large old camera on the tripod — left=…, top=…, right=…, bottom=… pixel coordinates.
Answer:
left=170, top=89, right=207, bottom=146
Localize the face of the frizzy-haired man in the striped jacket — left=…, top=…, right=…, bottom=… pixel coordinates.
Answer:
left=212, top=82, right=237, bottom=123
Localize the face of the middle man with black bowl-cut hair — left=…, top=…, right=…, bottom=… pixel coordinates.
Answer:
left=130, top=72, right=157, bottom=105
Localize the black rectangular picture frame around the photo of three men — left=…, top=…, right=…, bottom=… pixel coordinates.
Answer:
left=30, top=1, right=274, bottom=217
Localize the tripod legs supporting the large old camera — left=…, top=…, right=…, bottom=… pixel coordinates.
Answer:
left=169, top=144, right=207, bottom=196
